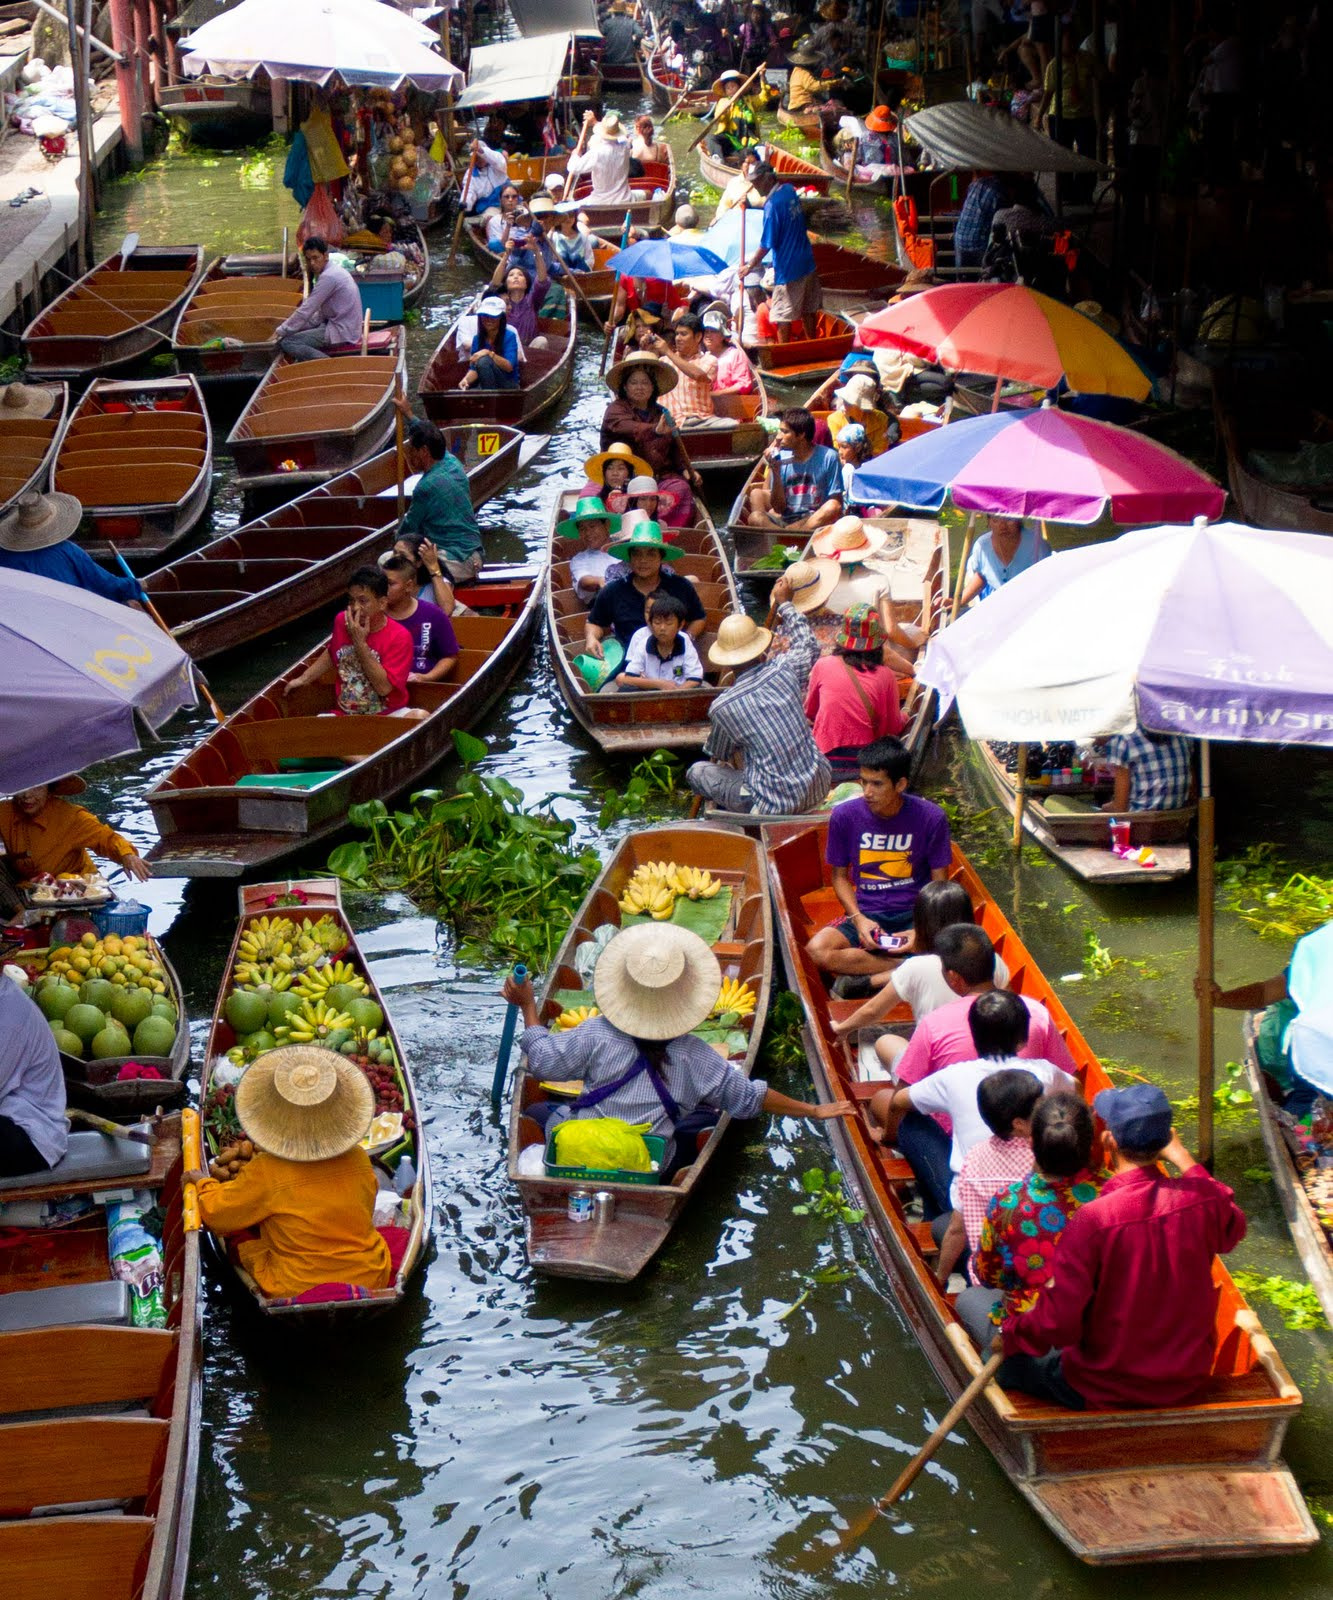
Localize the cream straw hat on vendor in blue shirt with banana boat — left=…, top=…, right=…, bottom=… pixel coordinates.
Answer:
left=588, top=923, right=722, bottom=1043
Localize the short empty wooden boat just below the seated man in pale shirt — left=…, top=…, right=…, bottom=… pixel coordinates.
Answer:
left=227, top=328, right=406, bottom=494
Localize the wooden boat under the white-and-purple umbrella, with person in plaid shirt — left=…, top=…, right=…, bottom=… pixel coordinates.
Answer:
left=970, top=741, right=1199, bottom=888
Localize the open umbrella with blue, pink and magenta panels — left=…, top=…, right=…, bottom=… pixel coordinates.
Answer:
left=851, top=406, right=1226, bottom=526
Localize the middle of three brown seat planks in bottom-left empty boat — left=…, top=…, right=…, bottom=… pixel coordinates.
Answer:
left=0, top=1416, right=171, bottom=1517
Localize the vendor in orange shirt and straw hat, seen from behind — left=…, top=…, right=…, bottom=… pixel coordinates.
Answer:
left=186, top=1045, right=392, bottom=1298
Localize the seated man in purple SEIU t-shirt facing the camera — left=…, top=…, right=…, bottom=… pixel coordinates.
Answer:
left=805, top=739, right=952, bottom=978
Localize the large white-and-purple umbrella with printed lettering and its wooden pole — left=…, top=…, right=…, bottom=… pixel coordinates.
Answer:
left=919, top=523, right=1333, bottom=1158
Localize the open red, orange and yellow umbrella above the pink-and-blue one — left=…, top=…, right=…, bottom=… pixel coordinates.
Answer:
left=859, top=283, right=1152, bottom=400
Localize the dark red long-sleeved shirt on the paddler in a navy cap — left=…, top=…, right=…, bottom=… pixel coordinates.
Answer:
left=1005, top=1166, right=1245, bottom=1406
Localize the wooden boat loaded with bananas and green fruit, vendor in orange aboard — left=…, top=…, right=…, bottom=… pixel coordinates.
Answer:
left=200, top=878, right=435, bottom=1326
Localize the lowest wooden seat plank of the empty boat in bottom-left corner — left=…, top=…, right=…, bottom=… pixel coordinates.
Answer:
left=0, top=1515, right=154, bottom=1600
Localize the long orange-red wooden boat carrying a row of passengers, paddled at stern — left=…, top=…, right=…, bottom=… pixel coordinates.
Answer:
left=763, top=822, right=1319, bottom=1565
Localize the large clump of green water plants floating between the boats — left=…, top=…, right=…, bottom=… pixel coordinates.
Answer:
left=328, top=733, right=598, bottom=970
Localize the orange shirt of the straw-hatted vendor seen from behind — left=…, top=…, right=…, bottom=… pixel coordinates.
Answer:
left=198, top=1146, right=389, bottom=1296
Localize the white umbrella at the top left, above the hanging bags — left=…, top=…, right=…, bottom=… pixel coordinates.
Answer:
left=181, top=0, right=462, bottom=90
